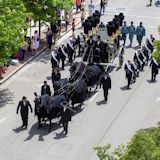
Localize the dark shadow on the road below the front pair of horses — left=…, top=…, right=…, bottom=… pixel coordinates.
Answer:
left=24, top=123, right=61, bottom=141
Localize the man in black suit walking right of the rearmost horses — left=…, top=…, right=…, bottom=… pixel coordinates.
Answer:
left=100, top=73, right=111, bottom=101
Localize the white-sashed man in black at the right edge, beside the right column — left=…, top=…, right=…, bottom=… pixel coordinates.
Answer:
left=150, top=58, right=159, bottom=81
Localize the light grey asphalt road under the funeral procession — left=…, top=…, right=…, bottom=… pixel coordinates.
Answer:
left=0, top=0, right=160, bottom=160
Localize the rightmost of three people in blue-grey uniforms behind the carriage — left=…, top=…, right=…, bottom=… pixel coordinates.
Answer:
left=136, top=22, right=146, bottom=47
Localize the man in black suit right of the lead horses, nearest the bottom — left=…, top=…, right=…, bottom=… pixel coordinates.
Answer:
left=60, top=103, right=71, bottom=135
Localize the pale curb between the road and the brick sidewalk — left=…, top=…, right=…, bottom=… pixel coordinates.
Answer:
left=0, top=20, right=81, bottom=85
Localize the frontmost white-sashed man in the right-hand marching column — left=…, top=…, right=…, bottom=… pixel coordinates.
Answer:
left=124, top=60, right=134, bottom=89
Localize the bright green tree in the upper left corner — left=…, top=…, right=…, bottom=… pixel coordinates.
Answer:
left=0, top=0, right=27, bottom=65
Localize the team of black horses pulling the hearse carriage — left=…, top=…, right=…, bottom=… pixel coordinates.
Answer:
left=34, top=62, right=104, bottom=132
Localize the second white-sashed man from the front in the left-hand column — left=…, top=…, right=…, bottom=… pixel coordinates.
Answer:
left=58, top=44, right=68, bottom=70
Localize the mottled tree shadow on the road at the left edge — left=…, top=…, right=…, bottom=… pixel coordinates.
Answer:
left=0, top=89, right=14, bottom=108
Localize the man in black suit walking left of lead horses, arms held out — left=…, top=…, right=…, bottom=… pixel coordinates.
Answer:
left=17, top=97, right=32, bottom=129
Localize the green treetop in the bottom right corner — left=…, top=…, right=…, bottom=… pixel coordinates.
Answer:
left=94, top=128, right=160, bottom=160
